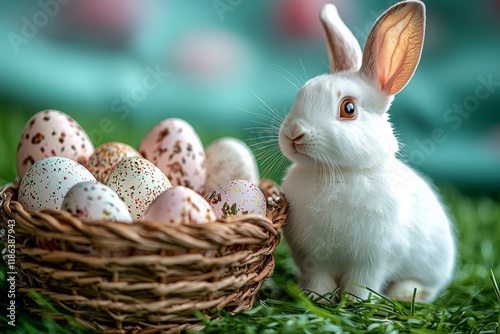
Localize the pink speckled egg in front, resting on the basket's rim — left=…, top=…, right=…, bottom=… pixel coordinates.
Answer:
left=141, top=186, right=215, bottom=225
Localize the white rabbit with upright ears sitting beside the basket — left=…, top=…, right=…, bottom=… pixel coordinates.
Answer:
left=279, top=1, right=456, bottom=302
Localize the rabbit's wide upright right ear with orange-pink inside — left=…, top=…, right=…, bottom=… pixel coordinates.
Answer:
left=361, top=1, right=425, bottom=95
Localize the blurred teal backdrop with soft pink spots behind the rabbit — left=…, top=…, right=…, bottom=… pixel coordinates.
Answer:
left=0, top=0, right=500, bottom=193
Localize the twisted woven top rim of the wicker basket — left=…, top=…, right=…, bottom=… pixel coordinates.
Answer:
left=0, top=180, right=287, bottom=249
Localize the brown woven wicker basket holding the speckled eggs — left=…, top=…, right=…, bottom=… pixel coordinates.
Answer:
left=0, top=180, right=287, bottom=333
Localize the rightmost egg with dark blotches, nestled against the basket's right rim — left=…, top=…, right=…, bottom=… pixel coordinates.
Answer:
left=205, top=180, right=267, bottom=218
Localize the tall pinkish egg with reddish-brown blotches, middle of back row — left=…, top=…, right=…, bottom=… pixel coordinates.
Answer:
left=139, top=118, right=207, bottom=194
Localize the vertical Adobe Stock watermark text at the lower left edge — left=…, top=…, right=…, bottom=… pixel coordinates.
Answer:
left=5, top=219, right=17, bottom=326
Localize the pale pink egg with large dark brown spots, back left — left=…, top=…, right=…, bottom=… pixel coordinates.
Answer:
left=17, top=110, right=94, bottom=177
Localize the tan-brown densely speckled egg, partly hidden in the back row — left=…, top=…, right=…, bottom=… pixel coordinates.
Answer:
left=86, top=142, right=141, bottom=183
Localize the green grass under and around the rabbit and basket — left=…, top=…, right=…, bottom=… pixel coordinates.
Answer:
left=0, top=108, right=500, bottom=334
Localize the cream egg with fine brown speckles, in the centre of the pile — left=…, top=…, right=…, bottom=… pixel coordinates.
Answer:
left=106, top=157, right=172, bottom=219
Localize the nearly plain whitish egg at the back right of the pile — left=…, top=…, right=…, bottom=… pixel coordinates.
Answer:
left=206, top=137, right=260, bottom=192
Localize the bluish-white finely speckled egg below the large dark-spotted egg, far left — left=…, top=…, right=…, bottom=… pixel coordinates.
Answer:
left=18, top=157, right=96, bottom=210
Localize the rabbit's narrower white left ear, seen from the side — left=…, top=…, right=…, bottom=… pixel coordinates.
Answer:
left=320, top=4, right=362, bottom=73
